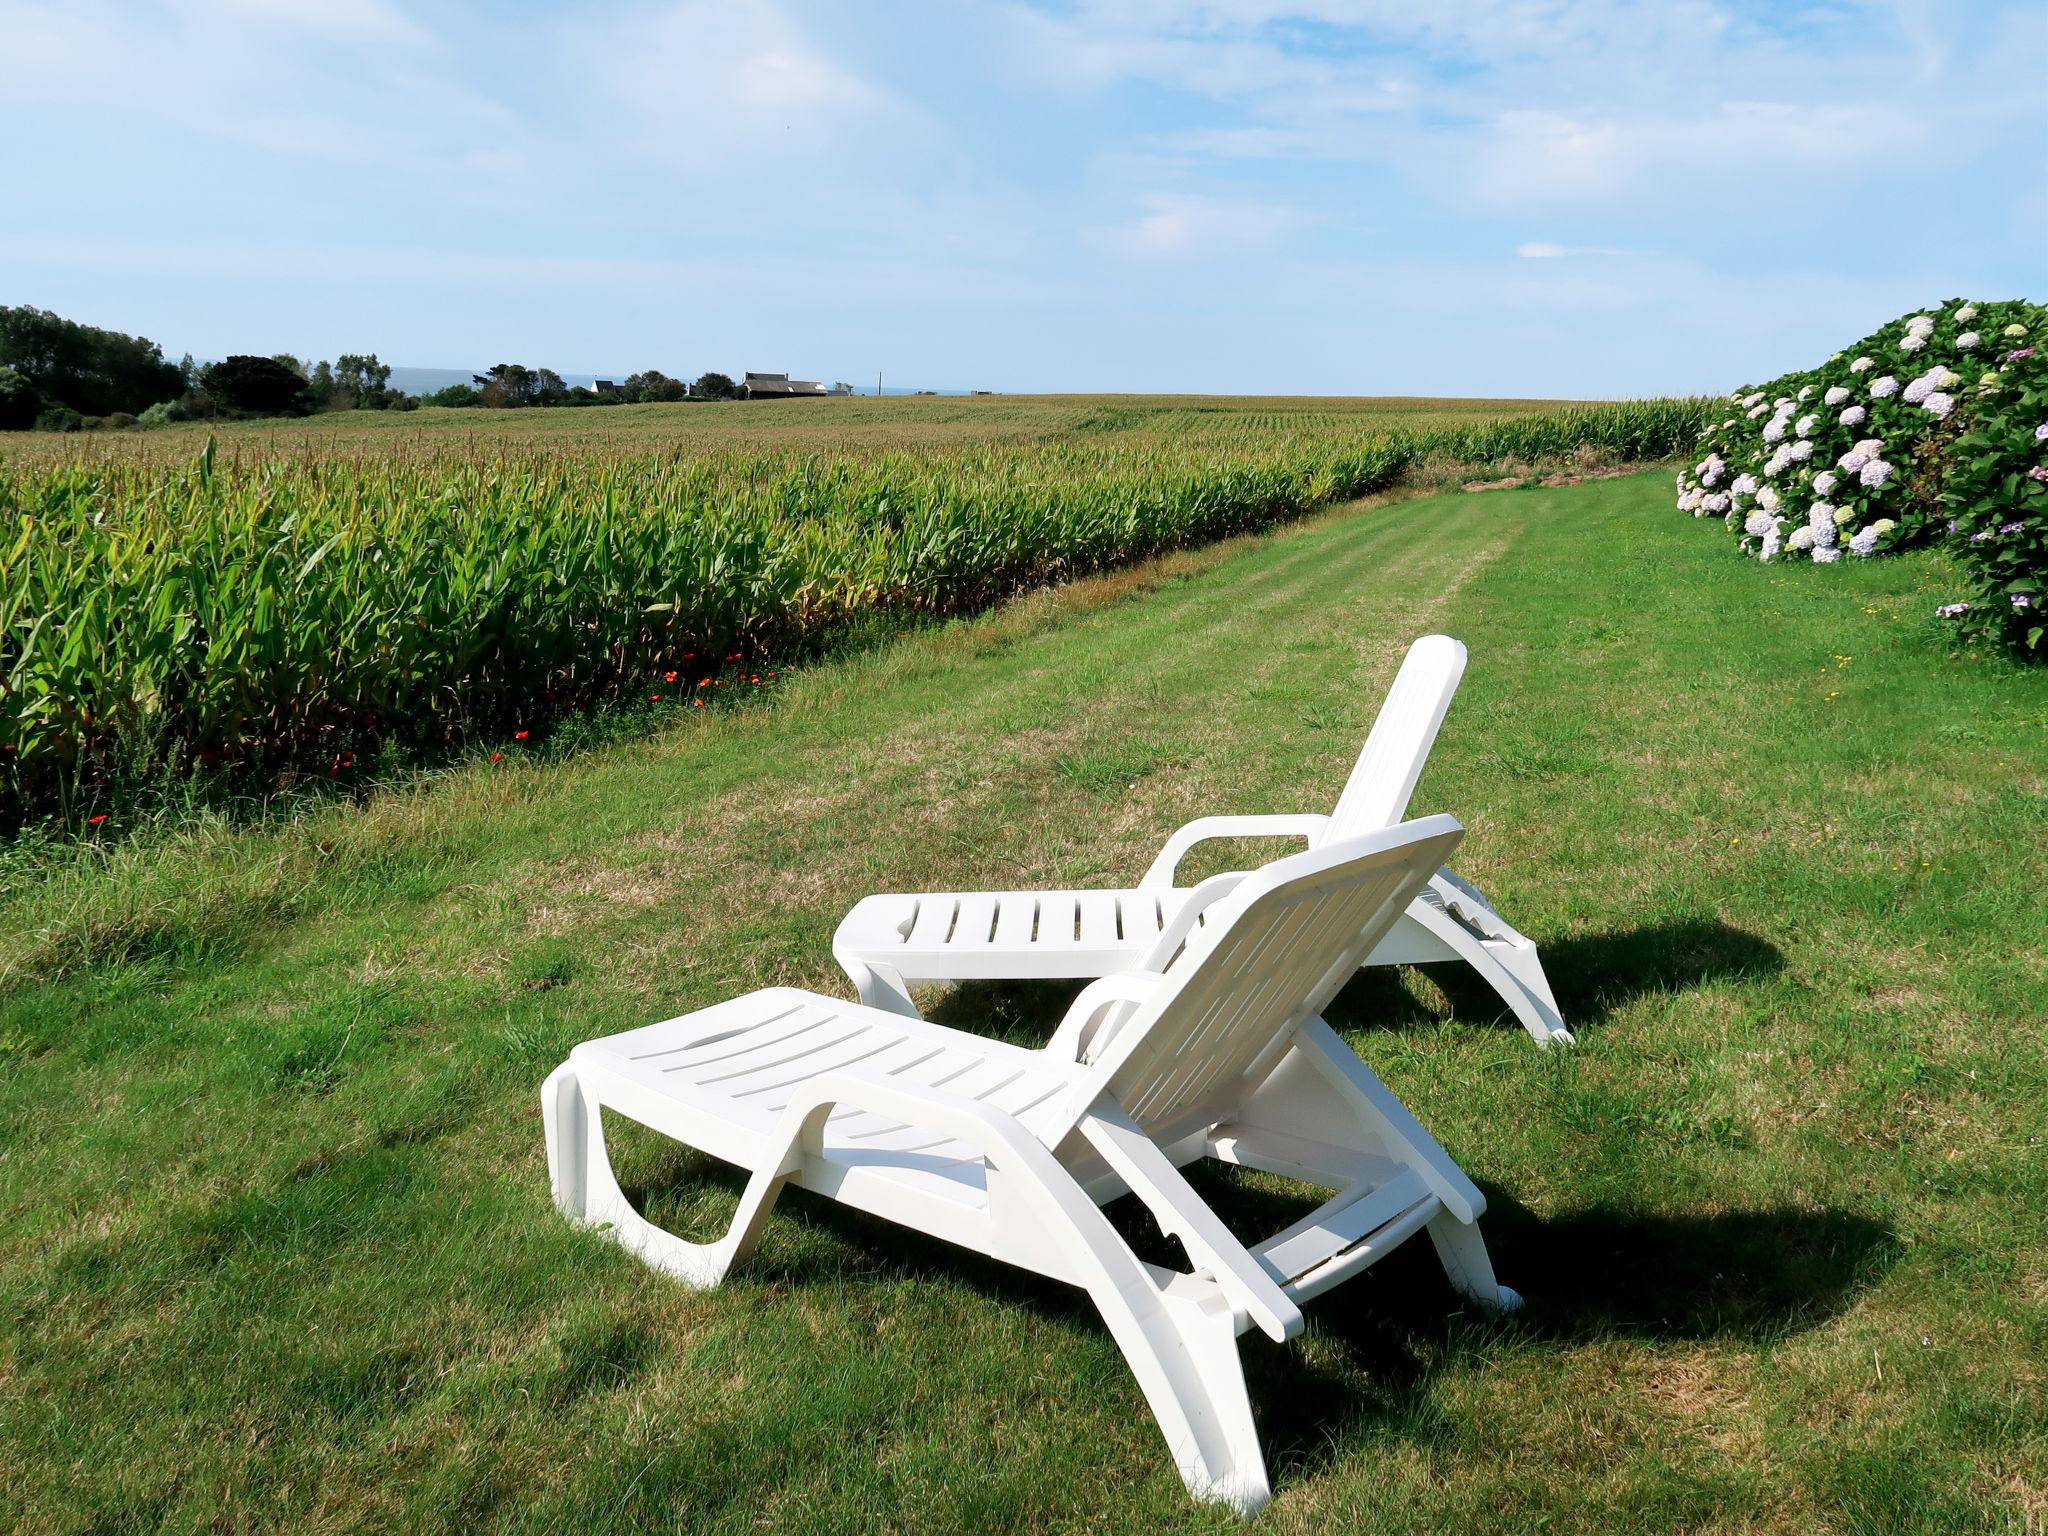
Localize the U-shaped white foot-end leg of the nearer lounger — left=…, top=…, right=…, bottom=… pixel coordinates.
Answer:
left=541, top=1063, right=788, bottom=1288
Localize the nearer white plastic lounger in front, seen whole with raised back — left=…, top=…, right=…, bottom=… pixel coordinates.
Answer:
left=541, top=815, right=1520, bottom=1513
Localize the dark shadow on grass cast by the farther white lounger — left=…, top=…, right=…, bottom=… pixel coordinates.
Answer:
left=1327, top=918, right=1784, bottom=1032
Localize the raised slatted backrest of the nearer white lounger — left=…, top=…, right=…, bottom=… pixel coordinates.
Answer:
left=1075, top=815, right=1464, bottom=1135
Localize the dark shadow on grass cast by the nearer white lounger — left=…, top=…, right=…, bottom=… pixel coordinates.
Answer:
left=598, top=1097, right=1903, bottom=1485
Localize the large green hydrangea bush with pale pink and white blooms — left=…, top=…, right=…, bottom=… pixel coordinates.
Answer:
left=1677, top=299, right=2048, bottom=651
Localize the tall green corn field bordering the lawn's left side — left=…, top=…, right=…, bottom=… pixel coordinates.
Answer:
left=0, top=401, right=1708, bottom=821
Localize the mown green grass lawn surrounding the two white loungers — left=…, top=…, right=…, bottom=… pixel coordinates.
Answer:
left=0, top=475, right=2048, bottom=1536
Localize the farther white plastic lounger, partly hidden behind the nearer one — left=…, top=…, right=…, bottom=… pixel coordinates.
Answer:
left=831, top=635, right=1571, bottom=1044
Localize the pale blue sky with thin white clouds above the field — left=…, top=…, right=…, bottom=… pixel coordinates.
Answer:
left=0, top=0, right=2048, bottom=395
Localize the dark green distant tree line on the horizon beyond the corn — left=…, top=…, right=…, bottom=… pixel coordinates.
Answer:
left=0, top=305, right=770, bottom=432
